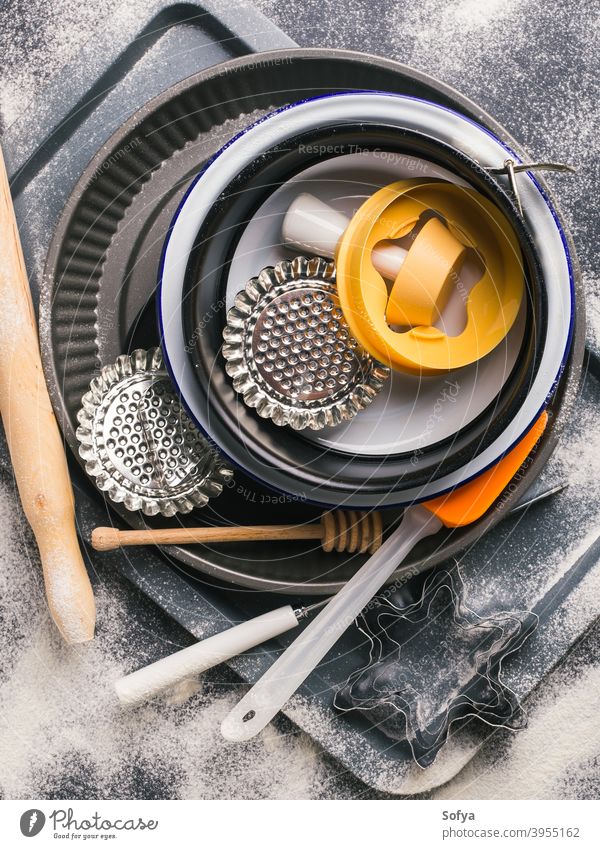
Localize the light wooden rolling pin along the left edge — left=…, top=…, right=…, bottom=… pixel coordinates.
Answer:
left=0, top=144, right=96, bottom=643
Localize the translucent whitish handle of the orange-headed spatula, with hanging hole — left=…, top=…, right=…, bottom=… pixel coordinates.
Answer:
left=221, top=506, right=442, bottom=742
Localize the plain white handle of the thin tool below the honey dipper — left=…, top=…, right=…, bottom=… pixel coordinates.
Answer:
left=115, top=604, right=298, bottom=705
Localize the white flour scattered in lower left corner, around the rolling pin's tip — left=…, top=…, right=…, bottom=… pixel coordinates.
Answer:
left=0, top=468, right=335, bottom=799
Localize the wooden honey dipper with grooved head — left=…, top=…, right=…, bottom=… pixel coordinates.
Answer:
left=92, top=510, right=383, bottom=554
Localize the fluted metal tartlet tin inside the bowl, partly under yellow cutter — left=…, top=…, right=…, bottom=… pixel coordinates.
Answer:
left=223, top=256, right=389, bottom=430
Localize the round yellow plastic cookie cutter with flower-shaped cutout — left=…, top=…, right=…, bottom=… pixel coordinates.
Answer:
left=336, top=179, right=525, bottom=374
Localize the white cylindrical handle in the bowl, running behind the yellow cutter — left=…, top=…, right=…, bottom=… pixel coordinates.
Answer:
left=281, top=193, right=407, bottom=280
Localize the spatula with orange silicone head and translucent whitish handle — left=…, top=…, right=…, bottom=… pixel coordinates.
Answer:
left=221, top=413, right=548, bottom=742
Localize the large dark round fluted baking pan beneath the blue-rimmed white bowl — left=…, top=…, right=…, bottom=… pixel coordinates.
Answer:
left=40, top=49, right=584, bottom=594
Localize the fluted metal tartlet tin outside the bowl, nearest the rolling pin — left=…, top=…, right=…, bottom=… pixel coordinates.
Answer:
left=77, top=348, right=233, bottom=516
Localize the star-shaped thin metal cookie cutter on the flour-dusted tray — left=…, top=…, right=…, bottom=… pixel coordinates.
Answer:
left=334, top=565, right=539, bottom=767
